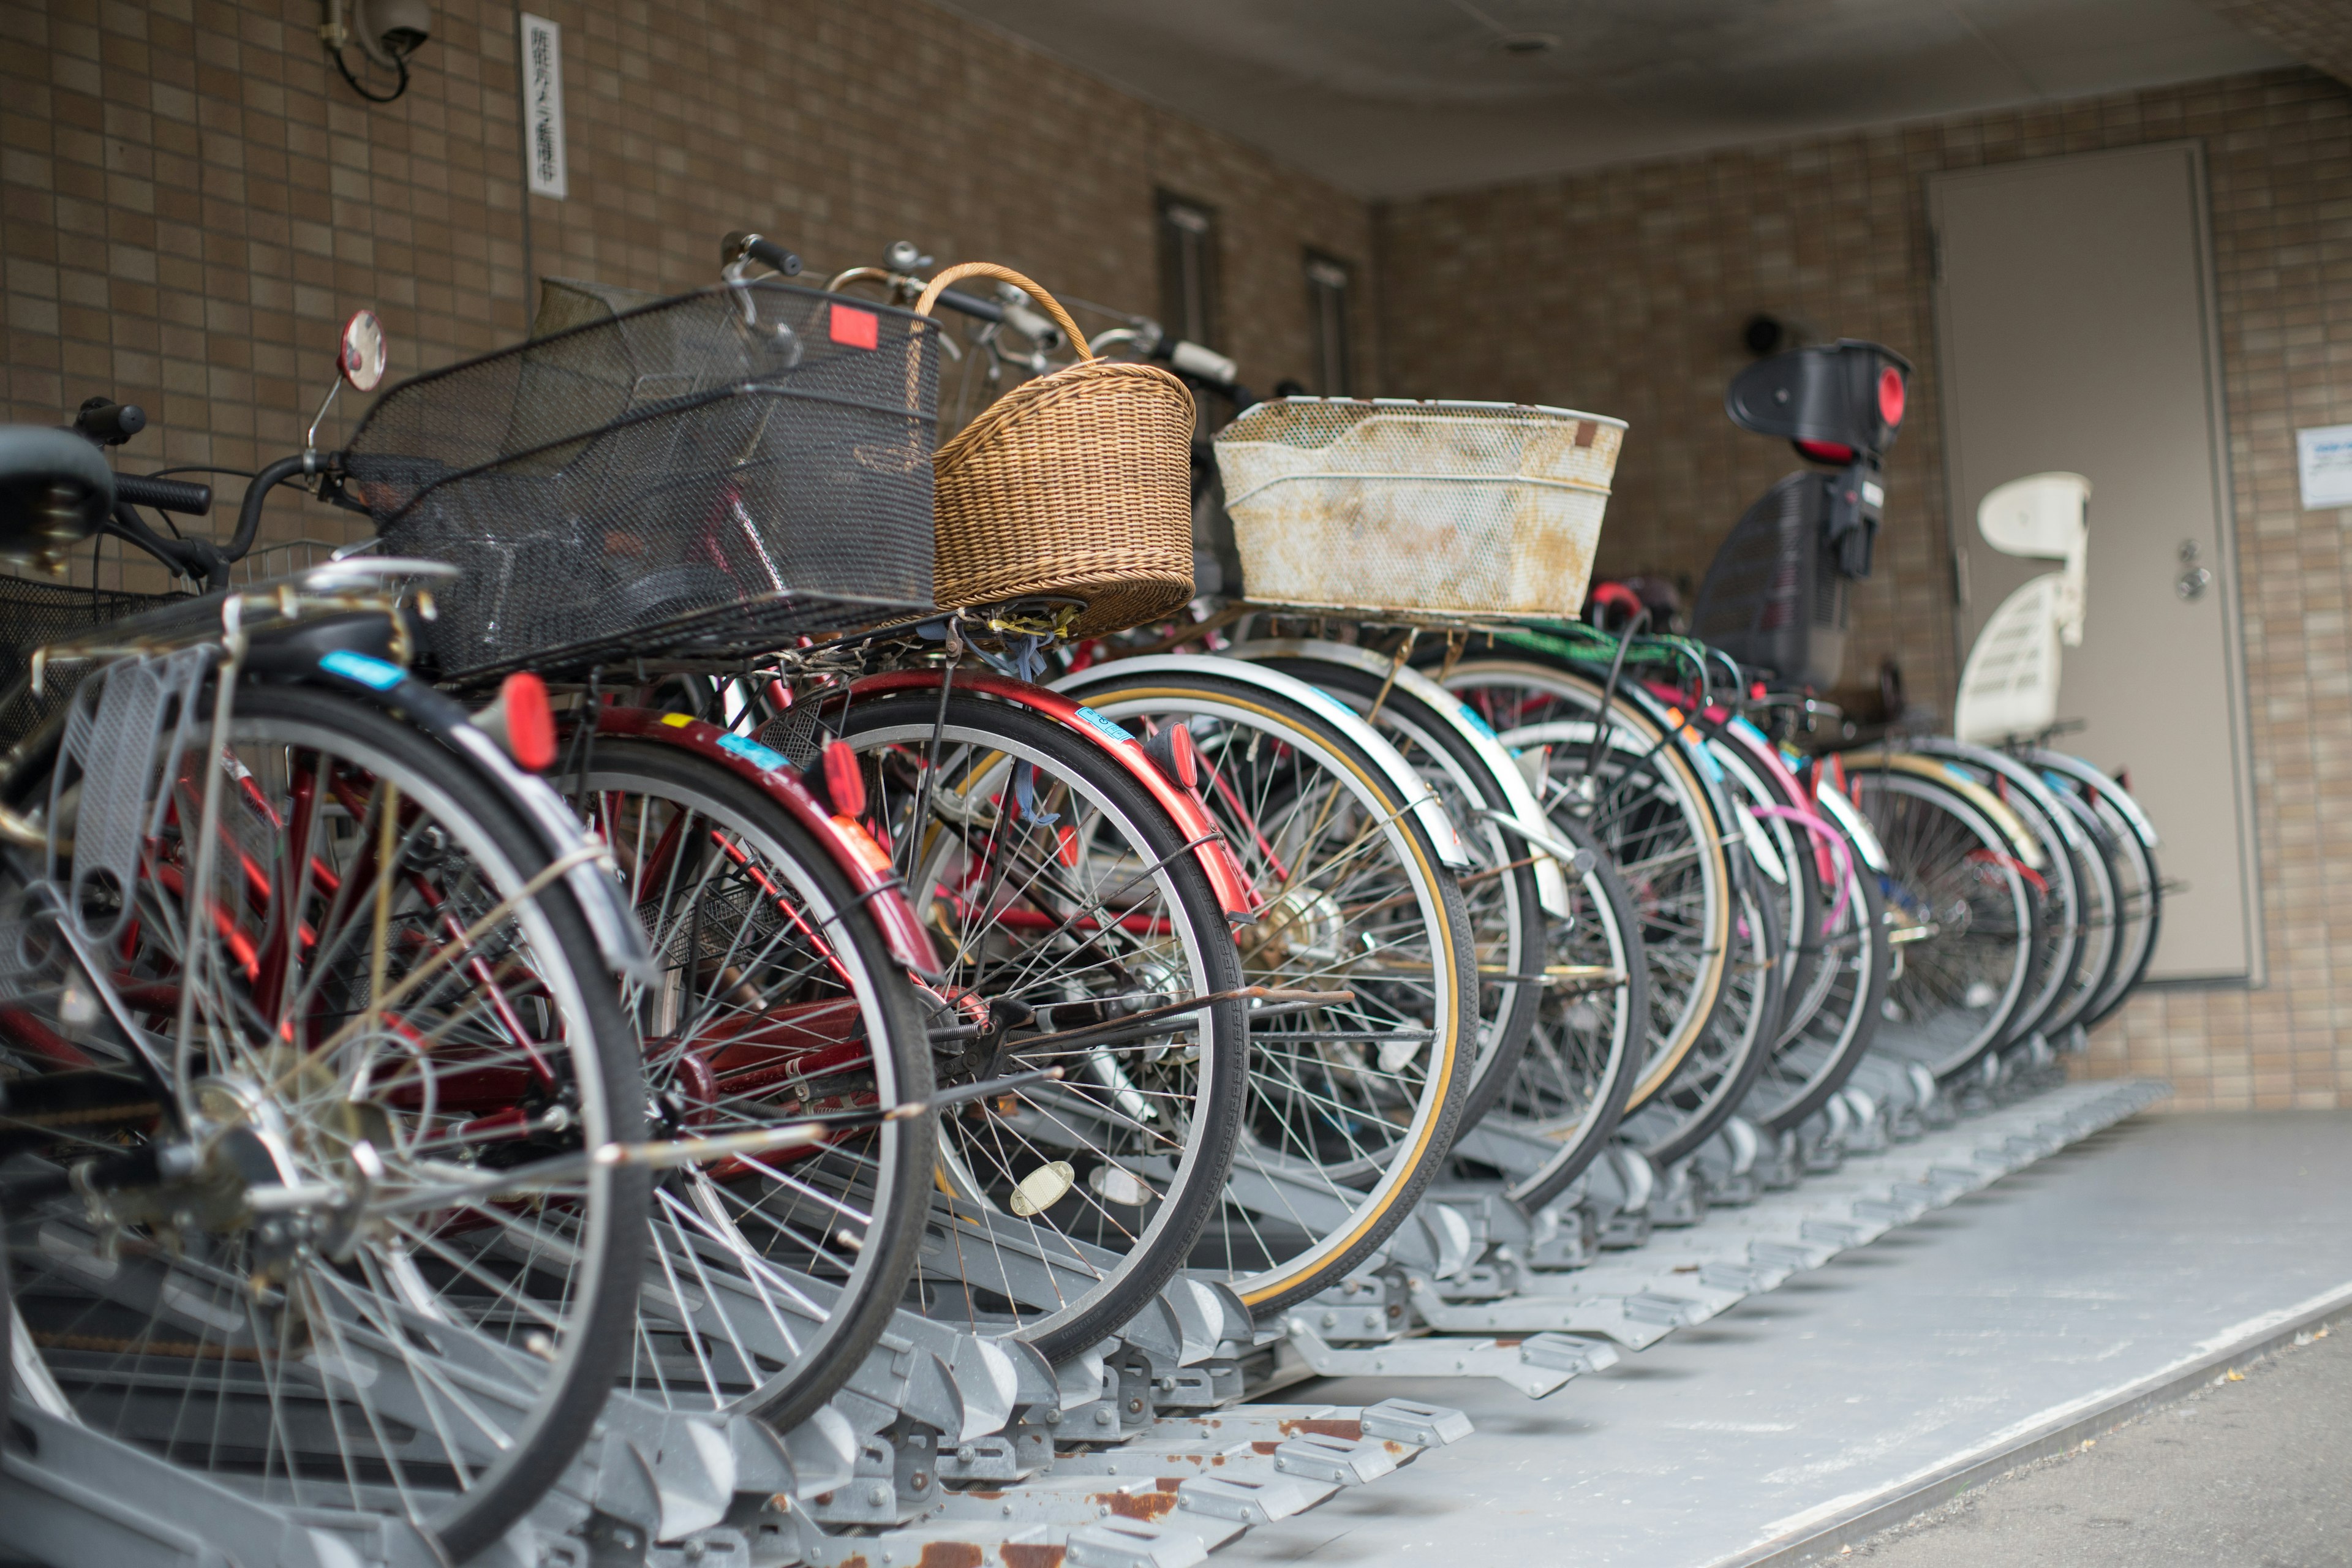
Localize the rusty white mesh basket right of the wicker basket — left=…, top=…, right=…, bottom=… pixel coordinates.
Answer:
left=1216, top=398, right=1625, bottom=616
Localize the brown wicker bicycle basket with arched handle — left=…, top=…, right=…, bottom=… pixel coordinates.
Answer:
left=915, top=261, right=1193, bottom=637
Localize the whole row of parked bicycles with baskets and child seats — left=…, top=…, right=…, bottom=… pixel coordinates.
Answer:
left=0, top=235, right=2162, bottom=1561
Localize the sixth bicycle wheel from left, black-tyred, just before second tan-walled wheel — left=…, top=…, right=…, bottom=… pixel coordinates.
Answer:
left=1456, top=804, right=1649, bottom=1211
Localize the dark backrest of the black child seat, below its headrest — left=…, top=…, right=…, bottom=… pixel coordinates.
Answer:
left=1691, top=472, right=1853, bottom=689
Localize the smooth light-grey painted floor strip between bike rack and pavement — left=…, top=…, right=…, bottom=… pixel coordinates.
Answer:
left=1216, top=1112, right=2352, bottom=1568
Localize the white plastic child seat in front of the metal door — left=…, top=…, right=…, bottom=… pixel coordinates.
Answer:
left=1952, top=472, right=2091, bottom=745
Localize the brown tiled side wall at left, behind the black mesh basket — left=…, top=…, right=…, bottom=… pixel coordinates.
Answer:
left=0, top=0, right=1374, bottom=557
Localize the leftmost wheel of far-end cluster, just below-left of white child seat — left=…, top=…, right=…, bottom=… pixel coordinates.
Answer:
left=1846, top=757, right=2041, bottom=1079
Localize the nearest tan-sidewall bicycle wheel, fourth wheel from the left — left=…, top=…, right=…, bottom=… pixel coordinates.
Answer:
left=1066, top=661, right=1477, bottom=1316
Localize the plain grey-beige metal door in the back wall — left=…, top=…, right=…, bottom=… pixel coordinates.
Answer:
left=1929, top=141, right=2263, bottom=982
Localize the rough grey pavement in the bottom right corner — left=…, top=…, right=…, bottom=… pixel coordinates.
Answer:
left=1853, top=1330, right=2352, bottom=1568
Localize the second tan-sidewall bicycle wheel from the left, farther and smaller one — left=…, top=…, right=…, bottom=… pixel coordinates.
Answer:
left=1444, top=661, right=1738, bottom=1107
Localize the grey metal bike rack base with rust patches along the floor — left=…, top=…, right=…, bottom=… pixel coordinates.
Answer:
left=0, top=1060, right=2168, bottom=1568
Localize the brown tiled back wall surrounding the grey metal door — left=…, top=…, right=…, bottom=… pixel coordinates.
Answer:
left=1381, top=70, right=2352, bottom=1107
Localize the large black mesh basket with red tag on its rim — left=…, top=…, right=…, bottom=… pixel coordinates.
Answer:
left=345, top=282, right=938, bottom=677
